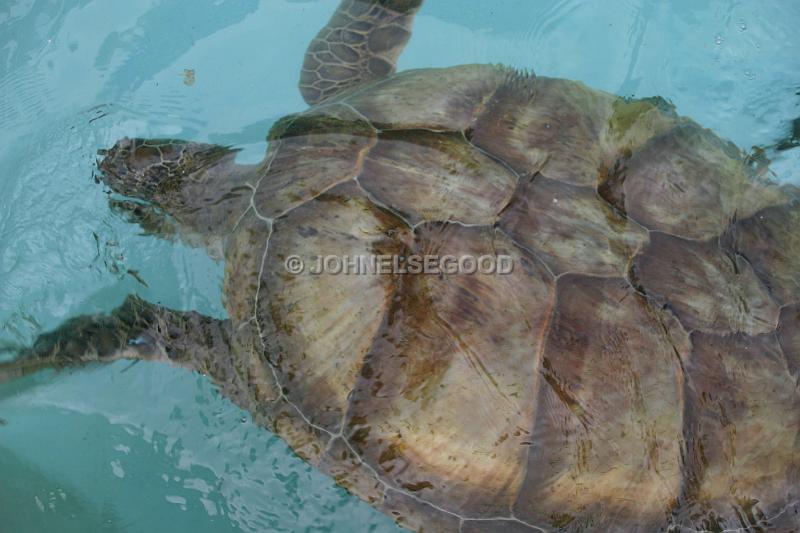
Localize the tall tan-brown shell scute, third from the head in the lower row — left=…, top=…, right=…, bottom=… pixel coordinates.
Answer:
left=514, top=274, right=688, bottom=532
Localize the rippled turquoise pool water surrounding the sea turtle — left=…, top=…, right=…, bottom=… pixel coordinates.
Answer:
left=0, top=0, right=800, bottom=532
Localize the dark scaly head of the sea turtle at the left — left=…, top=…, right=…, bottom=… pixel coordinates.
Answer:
left=98, top=138, right=236, bottom=204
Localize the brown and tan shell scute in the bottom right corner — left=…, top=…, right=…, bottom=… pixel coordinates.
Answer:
left=684, top=333, right=800, bottom=528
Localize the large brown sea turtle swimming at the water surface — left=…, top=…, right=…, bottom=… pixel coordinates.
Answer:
left=5, top=0, right=800, bottom=532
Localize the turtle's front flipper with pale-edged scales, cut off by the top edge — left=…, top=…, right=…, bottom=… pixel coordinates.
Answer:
left=300, top=0, right=422, bottom=105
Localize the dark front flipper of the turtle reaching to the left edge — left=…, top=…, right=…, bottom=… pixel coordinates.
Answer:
left=0, top=296, right=232, bottom=382
